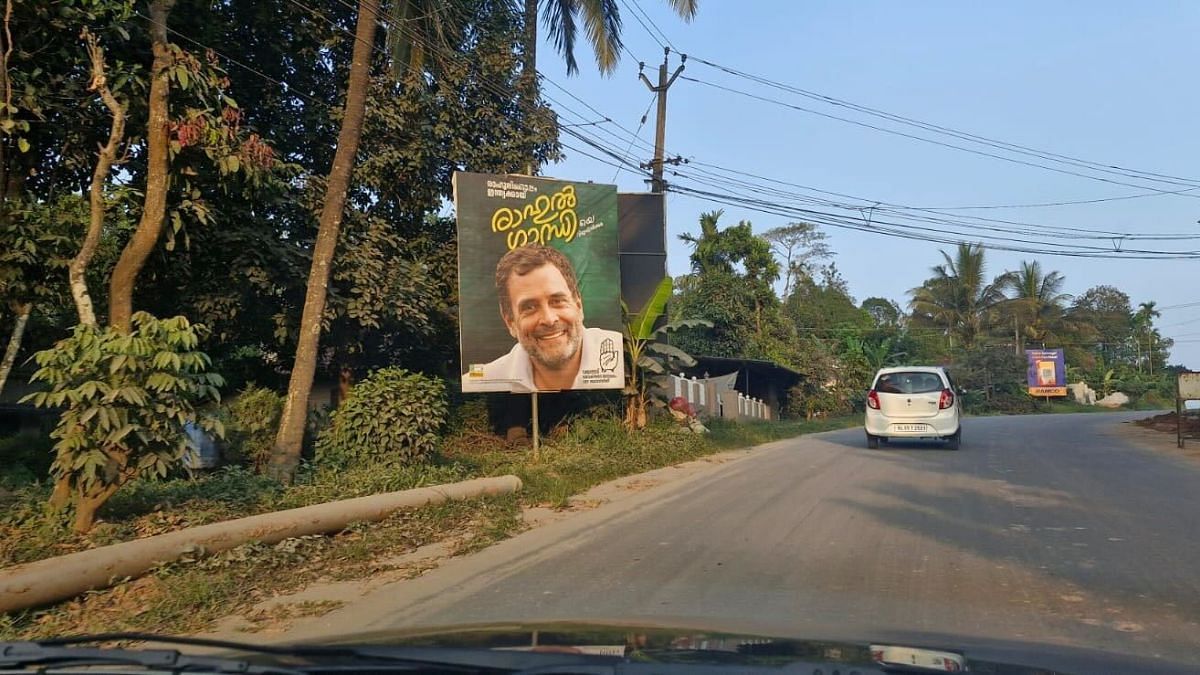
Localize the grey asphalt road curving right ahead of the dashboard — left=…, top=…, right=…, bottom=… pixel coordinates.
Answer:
left=283, top=413, right=1200, bottom=663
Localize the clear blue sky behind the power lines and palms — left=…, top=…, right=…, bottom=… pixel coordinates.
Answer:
left=539, top=0, right=1200, bottom=369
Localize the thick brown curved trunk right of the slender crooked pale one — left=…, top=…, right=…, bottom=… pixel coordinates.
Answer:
left=108, top=0, right=175, bottom=333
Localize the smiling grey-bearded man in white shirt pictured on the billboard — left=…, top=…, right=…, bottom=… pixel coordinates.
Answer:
left=467, top=244, right=624, bottom=392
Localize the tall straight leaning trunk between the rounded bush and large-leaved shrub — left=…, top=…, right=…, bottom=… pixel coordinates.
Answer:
left=268, top=0, right=378, bottom=483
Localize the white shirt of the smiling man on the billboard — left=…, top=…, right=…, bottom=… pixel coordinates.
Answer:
left=462, top=328, right=625, bottom=393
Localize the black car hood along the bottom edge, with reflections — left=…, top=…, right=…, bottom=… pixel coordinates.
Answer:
left=297, top=622, right=1198, bottom=675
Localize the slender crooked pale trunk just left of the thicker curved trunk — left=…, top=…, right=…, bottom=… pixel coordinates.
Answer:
left=67, top=29, right=125, bottom=325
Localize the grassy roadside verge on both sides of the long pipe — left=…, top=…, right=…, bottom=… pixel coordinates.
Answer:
left=0, top=408, right=860, bottom=639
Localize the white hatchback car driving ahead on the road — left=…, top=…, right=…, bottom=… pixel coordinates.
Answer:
left=865, top=366, right=962, bottom=450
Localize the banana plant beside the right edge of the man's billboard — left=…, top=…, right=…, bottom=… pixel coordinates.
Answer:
left=620, top=277, right=713, bottom=430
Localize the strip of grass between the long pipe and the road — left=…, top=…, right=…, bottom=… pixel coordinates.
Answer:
left=0, top=496, right=521, bottom=639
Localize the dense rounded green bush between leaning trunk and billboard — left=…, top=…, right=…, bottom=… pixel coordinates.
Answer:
left=316, top=368, right=448, bottom=466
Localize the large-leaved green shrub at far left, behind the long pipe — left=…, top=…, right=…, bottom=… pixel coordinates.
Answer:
left=24, top=312, right=223, bottom=530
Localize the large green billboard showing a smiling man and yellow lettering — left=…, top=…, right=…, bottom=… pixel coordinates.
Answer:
left=454, top=172, right=625, bottom=393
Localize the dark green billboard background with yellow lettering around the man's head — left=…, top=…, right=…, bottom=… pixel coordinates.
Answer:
left=454, top=173, right=622, bottom=371
